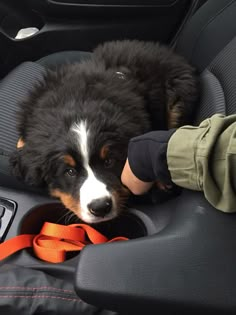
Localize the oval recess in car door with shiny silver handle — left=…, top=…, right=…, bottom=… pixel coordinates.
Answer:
left=0, top=9, right=45, bottom=40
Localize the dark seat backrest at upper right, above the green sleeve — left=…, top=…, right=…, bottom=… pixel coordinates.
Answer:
left=176, top=0, right=236, bottom=124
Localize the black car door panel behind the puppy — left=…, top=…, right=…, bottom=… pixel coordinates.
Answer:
left=0, top=0, right=202, bottom=77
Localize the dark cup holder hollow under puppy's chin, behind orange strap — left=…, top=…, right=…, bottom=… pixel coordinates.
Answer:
left=19, top=203, right=147, bottom=239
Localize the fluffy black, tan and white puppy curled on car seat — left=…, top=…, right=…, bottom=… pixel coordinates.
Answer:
left=11, top=41, right=198, bottom=223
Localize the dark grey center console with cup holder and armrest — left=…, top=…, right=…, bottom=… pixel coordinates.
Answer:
left=0, top=184, right=236, bottom=314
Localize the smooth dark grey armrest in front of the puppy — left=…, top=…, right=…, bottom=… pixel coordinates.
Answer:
left=76, top=191, right=236, bottom=314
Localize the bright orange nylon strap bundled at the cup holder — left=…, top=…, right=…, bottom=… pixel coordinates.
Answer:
left=0, top=222, right=127, bottom=263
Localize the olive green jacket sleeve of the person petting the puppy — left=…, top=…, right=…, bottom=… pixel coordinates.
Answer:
left=167, top=114, right=236, bottom=212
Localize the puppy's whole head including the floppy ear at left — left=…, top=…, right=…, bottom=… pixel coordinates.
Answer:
left=11, top=120, right=133, bottom=223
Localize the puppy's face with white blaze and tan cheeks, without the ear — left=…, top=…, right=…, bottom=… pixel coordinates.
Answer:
left=51, top=120, right=132, bottom=223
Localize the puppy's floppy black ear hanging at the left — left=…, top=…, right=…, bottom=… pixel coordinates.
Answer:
left=9, top=147, right=44, bottom=186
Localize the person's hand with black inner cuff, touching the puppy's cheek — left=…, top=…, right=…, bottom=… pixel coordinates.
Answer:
left=121, top=130, right=174, bottom=195
